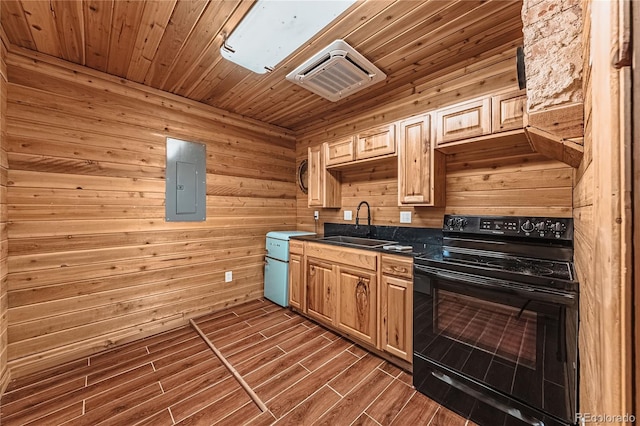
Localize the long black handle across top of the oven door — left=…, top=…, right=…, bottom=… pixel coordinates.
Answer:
left=413, top=264, right=576, bottom=305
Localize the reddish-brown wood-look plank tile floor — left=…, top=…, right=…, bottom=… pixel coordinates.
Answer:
left=0, top=300, right=471, bottom=426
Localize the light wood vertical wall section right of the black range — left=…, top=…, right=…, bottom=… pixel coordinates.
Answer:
left=573, top=1, right=638, bottom=415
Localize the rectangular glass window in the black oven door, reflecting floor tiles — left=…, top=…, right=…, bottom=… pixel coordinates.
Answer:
left=434, top=290, right=537, bottom=369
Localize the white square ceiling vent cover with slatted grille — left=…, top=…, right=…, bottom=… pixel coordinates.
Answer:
left=287, top=40, right=387, bottom=102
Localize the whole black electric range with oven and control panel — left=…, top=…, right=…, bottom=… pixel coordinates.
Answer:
left=413, top=215, right=578, bottom=426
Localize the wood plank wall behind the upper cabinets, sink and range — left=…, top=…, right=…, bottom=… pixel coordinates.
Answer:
left=297, top=52, right=573, bottom=232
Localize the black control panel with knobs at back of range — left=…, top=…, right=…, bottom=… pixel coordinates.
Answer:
left=442, top=215, right=573, bottom=240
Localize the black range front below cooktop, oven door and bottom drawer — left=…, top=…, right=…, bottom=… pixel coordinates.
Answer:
left=413, top=263, right=578, bottom=425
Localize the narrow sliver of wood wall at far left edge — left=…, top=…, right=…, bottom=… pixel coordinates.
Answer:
left=0, top=28, right=10, bottom=395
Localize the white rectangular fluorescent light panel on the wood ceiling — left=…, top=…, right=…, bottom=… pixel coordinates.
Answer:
left=220, top=0, right=355, bottom=74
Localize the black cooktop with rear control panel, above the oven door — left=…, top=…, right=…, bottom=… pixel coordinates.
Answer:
left=414, top=215, right=578, bottom=291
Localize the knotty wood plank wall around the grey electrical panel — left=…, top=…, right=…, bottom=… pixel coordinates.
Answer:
left=7, top=48, right=296, bottom=377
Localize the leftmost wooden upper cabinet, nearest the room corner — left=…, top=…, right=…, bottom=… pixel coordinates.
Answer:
left=307, top=145, right=341, bottom=208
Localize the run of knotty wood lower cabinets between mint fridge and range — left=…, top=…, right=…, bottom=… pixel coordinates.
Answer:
left=298, top=242, right=413, bottom=370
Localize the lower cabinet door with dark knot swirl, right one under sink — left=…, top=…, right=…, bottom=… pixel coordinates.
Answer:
left=336, top=266, right=377, bottom=346
